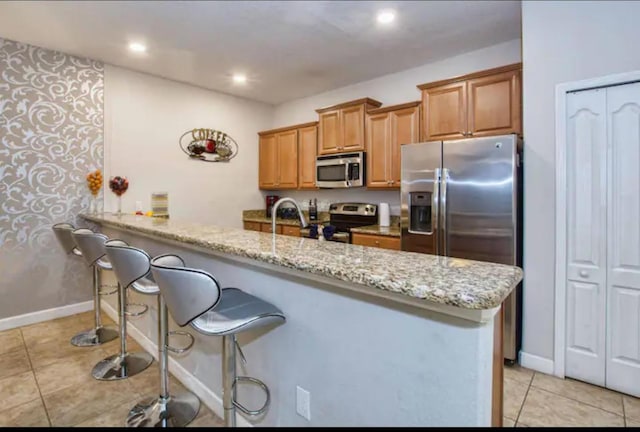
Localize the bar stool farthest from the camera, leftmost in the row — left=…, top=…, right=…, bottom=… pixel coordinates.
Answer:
left=53, top=223, right=118, bottom=347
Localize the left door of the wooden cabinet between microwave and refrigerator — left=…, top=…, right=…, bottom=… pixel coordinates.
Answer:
left=367, top=113, right=390, bottom=188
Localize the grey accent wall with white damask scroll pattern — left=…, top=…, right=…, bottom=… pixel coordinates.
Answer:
left=0, top=38, right=104, bottom=319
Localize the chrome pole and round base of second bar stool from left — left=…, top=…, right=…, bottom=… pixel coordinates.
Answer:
left=91, top=283, right=153, bottom=381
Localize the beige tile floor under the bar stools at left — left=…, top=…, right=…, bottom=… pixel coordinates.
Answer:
left=0, top=312, right=223, bottom=427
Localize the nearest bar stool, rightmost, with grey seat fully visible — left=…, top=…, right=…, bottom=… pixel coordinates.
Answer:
left=151, top=254, right=285, bottom=427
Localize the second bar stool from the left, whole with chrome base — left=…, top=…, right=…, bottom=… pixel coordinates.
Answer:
left=71, top=228, right=153, bottom=381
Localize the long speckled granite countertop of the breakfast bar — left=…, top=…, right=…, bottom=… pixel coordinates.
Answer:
left=81, top=213, right=522, bottom=310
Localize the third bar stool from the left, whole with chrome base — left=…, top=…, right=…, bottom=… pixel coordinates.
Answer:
left=106, top=240, right=200, bottom=427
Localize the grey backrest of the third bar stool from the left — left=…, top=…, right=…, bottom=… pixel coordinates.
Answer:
left=105, top=240, right=151, bottom=288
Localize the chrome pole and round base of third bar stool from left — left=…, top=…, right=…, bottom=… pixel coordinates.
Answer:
left=125, top=295, right=200, bottom=427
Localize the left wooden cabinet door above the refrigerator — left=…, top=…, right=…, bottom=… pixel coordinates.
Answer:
left=422, top=82, right=467, bottom=141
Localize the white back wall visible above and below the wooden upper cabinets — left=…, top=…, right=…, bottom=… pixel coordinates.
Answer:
left=263, top=39, right=521, bottom=215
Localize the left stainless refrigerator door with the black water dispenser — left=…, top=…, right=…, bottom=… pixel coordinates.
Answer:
left=400, top=141, right=442, bottom=254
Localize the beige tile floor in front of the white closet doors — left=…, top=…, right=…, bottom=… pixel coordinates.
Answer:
left=504, top=366, right=640, bottom=427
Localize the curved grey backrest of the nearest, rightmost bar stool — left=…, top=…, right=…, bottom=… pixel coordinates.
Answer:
left=151, top=254, right=221, bottom=327
